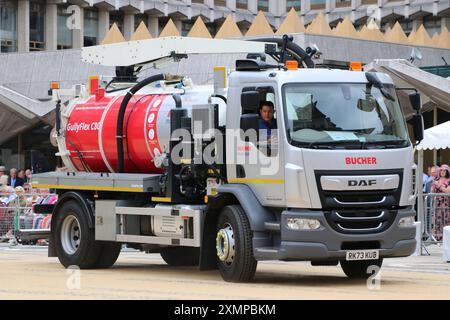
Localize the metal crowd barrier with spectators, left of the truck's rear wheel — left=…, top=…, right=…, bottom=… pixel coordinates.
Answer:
left=0, top=191, right=56, bottom=244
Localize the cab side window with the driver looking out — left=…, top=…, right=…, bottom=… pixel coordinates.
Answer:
left=241, top=86, right=278, bottom=156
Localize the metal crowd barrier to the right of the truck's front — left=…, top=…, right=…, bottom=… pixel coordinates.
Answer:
left=422, top=193, right=450, bottom=245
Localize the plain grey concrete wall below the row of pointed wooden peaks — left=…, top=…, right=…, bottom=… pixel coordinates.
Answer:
left=0, top=33, right=450, bottom=111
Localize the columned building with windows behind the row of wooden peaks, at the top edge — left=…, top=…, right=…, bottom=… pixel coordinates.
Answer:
left=0, top=0, right=450, bottom=52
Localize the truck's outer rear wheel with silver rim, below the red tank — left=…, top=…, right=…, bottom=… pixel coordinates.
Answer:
left=54, top=201, right=102, bottom=269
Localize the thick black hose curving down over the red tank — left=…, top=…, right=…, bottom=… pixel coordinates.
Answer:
left=116, top=73, right=165, bottom=173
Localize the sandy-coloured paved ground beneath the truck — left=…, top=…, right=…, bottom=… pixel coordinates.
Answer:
left=0, top=244, right=450, bottom=300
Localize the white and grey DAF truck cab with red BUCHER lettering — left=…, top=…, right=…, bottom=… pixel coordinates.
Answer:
left=219, top=65, right=416, bottom=276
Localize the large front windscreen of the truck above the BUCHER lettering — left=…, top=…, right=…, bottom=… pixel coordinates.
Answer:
left=283, top=83, right=409, bottom=148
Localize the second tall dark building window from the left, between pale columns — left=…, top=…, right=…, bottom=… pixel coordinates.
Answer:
left=30, top=1, right=45, bottom=51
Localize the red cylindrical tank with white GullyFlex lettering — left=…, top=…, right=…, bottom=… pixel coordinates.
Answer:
left=63, top=89, right=220, bottom=173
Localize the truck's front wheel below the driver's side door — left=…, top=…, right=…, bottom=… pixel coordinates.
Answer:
left=216, top=205, right=258, bottom=282
